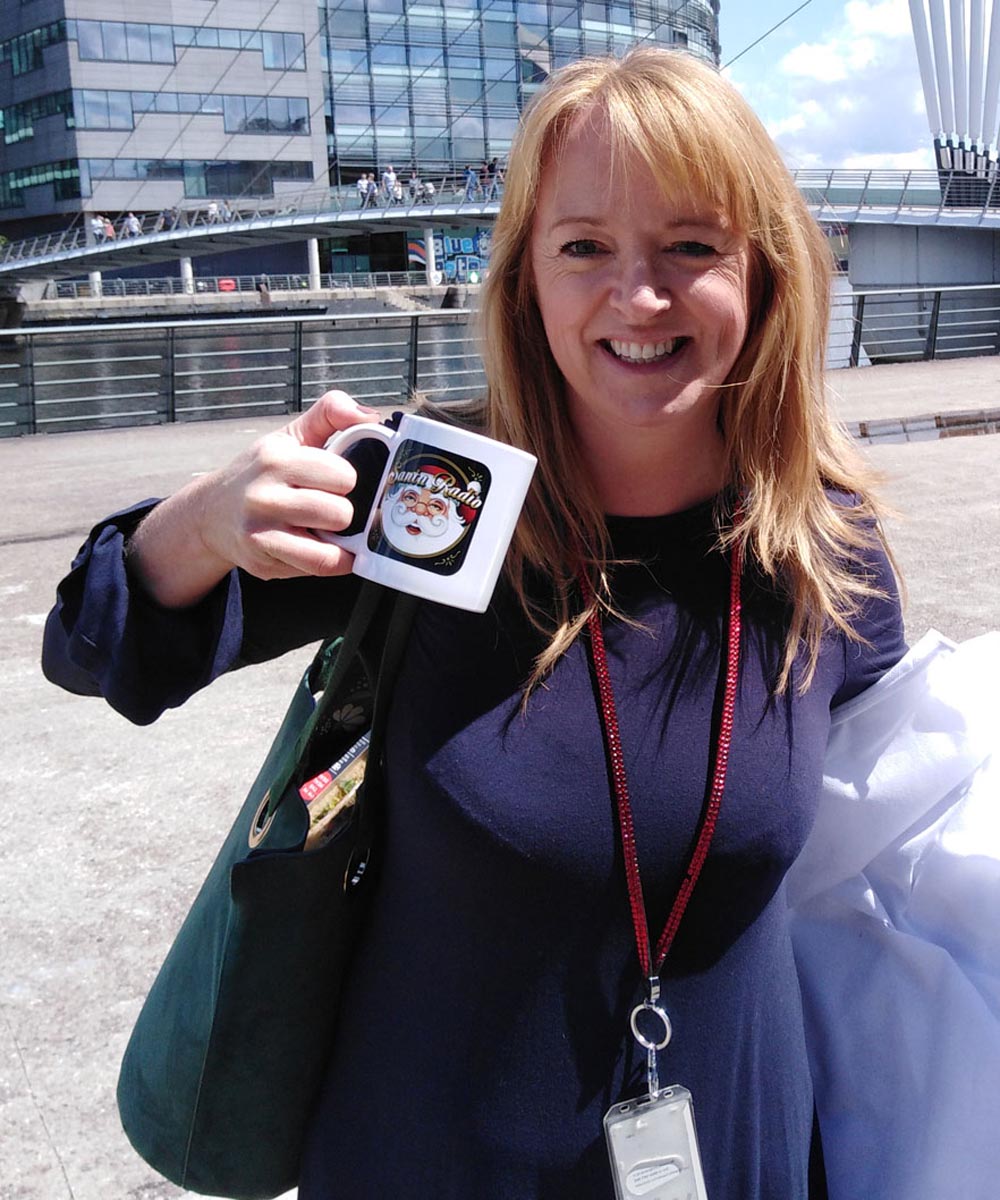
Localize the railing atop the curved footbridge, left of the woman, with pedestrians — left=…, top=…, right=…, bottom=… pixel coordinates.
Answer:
left=0, top=175, right=503, bottom=264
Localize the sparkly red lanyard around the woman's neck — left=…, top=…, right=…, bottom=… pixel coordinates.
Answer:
left=581, top=544, right=742, bottom=982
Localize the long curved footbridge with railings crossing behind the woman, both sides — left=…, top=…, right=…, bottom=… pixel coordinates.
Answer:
left=0, top=169, right=1000, bottom=283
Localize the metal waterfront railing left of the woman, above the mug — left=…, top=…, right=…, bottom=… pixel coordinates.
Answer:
left=0, top=310, right=485, bottom=436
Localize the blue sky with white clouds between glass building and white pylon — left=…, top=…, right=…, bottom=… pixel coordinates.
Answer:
left=719, top=0, right=934, bottom=169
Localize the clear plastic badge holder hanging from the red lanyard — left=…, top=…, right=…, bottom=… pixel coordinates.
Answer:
left=604, top=1085, right=708, bottom=1200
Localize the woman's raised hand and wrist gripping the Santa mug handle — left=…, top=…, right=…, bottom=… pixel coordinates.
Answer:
left=128, top=391, right=378, bottom=607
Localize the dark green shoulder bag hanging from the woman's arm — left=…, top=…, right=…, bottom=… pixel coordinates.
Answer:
left=118, top=581, right=418, bottom=1200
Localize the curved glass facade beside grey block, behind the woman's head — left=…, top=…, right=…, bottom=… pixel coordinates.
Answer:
left=319, top=0, right=719, bottom=182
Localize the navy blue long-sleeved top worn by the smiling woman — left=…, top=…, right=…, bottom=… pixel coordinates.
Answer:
left=46, top=492, right=905, bottom=1200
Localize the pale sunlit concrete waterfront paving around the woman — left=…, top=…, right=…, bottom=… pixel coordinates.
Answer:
left=0, top=358, right=1000, bottom=1200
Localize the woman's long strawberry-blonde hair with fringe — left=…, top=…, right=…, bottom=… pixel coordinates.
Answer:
left=439, top=48, right=876, bottom=690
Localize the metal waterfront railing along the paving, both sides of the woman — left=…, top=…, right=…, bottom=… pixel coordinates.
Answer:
left=0, top=280, right=1000, bottom=436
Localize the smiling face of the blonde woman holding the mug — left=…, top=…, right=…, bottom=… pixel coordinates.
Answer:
left=529, top=112, right=749, bottom=470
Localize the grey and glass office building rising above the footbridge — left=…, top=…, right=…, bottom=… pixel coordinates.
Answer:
left=0, top=0, right=719, bottom=238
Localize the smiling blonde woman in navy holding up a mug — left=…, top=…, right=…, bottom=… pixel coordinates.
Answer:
left=46, top=50, right=904, bottom=1200
